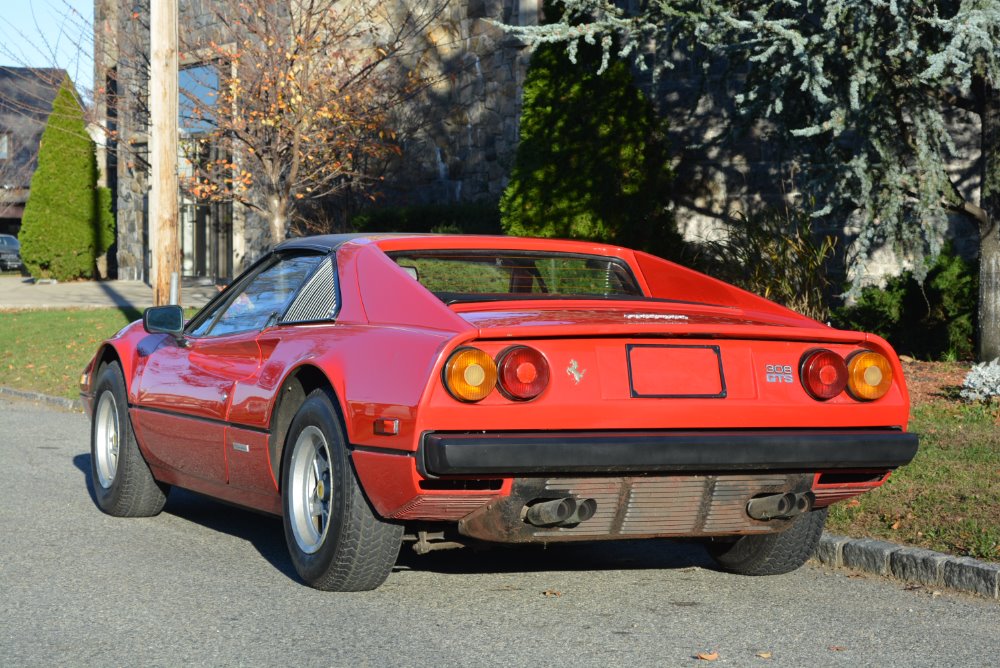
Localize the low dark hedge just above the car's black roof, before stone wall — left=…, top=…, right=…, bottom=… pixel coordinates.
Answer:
left=351, top=202, right=501, bottom=234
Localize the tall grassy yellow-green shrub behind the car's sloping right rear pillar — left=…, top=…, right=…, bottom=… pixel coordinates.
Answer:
left=693, top=208, right=837, bottom=321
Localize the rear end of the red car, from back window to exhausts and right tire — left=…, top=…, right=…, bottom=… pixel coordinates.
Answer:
left=354, top=240, right=917, bottom=574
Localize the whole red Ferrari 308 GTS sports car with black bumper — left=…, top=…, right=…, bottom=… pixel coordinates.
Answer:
left=81, top=235, right=917, bottom=591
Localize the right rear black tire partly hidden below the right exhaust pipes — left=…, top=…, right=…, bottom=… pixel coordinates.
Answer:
left=708, top=508, right=827, bottom=575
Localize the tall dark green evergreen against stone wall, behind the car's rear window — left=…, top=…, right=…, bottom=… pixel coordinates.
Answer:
left=500, top=37, right=682, bottom=257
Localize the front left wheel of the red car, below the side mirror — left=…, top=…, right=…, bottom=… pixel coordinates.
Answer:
left=90, top=362, right=170, bottom=517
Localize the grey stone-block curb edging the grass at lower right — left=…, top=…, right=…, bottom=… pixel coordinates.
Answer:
left=815, top=533, right=1000, bottom=599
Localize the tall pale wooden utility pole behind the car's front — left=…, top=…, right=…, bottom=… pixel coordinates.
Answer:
left=149, top=0, right=181, bottom=306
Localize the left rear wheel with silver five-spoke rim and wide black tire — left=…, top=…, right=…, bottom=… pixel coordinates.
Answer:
left=281, top=390, right=403, bottom=591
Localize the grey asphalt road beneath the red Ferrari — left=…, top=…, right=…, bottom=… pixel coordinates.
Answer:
left=0, top=400, right=1000, bottom=667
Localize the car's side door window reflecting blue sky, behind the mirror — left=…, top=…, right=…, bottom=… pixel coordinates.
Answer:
left=191, top=255, right=323, bottom=336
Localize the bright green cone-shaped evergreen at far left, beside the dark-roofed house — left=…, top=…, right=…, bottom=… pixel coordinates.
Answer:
left=19, top=78, right=114, bottom=280
